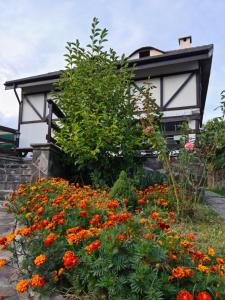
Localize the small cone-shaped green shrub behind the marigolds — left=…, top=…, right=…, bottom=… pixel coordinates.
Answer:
left=109, top=171, right=137, bottom=207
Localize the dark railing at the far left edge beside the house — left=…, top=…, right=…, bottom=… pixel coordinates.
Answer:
left=0, top=126, right=19, bottom=155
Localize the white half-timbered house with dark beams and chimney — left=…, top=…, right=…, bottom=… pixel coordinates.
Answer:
left=5, top=36, right=213, bottom=149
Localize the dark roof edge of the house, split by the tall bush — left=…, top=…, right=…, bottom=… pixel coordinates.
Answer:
left=4, top=44, right=213, bottom=89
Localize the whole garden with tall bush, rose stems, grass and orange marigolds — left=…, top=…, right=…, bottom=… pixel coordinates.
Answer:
left=0, top=18, right=225, bottom=300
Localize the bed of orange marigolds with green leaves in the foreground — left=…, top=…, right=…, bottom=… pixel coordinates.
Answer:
left=0, top=178, right=225, bottom=300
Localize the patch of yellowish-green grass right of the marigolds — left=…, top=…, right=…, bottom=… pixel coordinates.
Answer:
left=173, top=203, right=225, bottom=256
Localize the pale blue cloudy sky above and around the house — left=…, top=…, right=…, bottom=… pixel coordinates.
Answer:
left=0, top=0, right=225, bottom=128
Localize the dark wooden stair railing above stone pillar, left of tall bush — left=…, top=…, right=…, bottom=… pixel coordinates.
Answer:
left=46, top=99, right=65, bottom=144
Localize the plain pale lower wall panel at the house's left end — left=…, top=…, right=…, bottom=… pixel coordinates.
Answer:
left=19, top=123, right=48, bottom=148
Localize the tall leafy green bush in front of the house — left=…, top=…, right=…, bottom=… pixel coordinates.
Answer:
left=54, top=18, right=143, bottom=183
